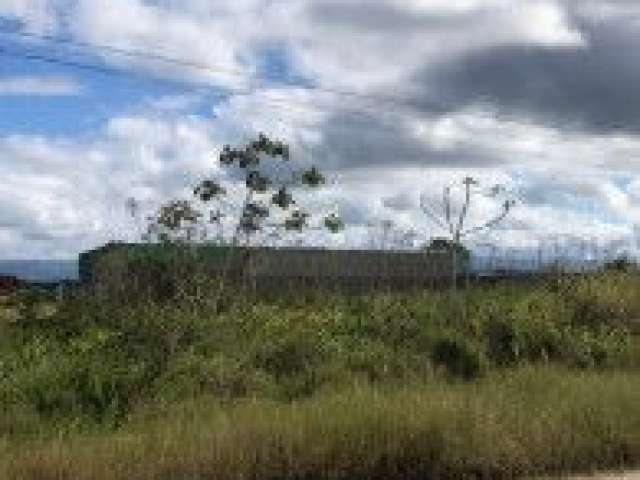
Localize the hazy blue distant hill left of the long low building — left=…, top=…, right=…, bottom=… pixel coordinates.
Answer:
left=0, top=260, right=79, bottom=282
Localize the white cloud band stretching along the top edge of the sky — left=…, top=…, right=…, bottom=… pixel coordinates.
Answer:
left=6, top=0, right=584, bottom=95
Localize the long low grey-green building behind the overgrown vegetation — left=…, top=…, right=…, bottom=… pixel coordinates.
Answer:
left=79, top=243, right=465, bottom=298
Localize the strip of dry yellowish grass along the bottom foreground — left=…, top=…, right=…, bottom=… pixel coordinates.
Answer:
left=0, top=367, right=640, bottom=480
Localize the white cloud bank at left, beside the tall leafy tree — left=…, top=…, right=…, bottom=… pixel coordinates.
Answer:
left=0, top=112, right=220, bottom=258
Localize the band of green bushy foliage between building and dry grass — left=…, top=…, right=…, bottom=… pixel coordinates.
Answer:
left=0, top=268, right=639, bottom=440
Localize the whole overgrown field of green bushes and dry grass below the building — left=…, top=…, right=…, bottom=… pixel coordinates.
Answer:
left=0, top=264, right=640, bottom=480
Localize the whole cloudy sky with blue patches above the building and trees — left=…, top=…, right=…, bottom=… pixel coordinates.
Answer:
left=0, top=0, right=640, bottom=259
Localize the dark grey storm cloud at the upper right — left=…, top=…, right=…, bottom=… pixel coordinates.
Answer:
left=415, top=15, right=640, bottom=132
